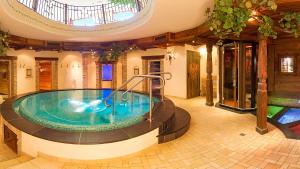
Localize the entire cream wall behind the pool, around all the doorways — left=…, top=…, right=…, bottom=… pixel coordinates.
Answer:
left=8, top=45, right=218, bottom=98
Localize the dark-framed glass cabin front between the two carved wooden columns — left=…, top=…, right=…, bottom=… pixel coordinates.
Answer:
left=220, top=41, right=257, bottom=110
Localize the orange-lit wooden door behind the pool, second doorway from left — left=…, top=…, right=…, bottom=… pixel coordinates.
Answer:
left=39, top=61, right=52, bottom=90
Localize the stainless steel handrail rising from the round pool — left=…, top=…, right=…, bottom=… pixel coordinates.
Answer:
left=104, top=75, right=165, bottom=122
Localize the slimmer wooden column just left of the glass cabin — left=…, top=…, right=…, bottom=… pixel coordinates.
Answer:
left=206, top=43, right=214, bottom=106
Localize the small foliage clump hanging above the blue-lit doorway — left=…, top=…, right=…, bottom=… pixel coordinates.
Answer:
left=99, top=43, right=128, bottom=62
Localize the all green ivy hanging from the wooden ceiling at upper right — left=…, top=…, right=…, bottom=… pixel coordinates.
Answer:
left=206, top=0, right=300, bottom=44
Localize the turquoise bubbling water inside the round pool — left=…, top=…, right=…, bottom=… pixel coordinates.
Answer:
left=13, top=90, right=159, bottom=131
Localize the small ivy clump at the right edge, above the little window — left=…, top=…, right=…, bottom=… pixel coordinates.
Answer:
left=279, top=12, right=300, bottom=38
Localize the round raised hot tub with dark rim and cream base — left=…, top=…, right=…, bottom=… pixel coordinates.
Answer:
left=1, top=89, right=175, bottom=160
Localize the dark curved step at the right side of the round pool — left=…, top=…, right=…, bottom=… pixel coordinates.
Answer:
left=158, top=107, right=191, bottom=144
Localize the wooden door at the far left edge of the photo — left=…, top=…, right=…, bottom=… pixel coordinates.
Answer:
left=0, top=61, right=10, bottom=95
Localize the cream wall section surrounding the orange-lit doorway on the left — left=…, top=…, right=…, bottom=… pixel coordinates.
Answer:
left=7, top=49, right=82, bottom=94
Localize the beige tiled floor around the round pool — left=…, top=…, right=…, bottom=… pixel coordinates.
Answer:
left=0, top=98, right=300, bottom=169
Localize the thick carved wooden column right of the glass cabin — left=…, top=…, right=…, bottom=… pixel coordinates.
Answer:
left=256, top=35, right=268, bottom=134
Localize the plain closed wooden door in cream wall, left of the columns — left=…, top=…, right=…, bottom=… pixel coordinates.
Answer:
left=187, top=51, right=200, bottom=98
